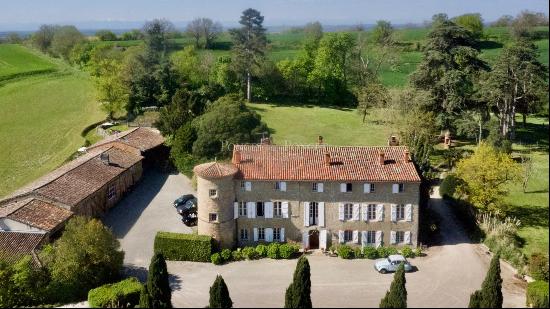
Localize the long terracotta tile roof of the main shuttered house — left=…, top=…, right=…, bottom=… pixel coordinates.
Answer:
left=233, top=145, right=420, bottom=182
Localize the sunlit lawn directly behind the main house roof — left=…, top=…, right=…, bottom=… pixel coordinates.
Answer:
left=248, top=103, right=391, bottom=145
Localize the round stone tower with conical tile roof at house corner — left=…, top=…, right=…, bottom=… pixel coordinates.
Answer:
left=193, top=162, right=238, bottom=248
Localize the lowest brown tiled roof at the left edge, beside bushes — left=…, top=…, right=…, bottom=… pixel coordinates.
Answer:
left=0, top=232, right=44, bottom=265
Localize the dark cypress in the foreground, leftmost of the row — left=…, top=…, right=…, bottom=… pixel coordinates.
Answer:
left=147, top=253, right=172, bottom=308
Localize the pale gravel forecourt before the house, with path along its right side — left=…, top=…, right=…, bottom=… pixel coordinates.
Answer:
left=168, top=184, right=525, bottom=307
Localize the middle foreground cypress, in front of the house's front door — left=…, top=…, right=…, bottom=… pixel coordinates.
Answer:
left=285, top=256, right=312, bottom=308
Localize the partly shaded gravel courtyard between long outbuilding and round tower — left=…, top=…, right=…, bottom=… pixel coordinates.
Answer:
left=103, top=169, right=195, bottom=267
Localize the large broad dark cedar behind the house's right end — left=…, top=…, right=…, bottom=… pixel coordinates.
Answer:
left=410, top=14, right=487, bottom=129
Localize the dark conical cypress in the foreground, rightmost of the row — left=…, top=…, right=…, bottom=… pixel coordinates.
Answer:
left=480, top=254, right=502, bottom=308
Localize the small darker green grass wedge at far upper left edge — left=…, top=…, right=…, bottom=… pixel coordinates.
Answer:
left=0, top=44, right=56, bottom=81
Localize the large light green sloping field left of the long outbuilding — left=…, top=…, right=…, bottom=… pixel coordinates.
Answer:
left=0, top=45, right=105, bottom=197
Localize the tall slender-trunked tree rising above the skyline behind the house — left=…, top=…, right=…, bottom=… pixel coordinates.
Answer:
left=230, top=9, right=267, bottom=101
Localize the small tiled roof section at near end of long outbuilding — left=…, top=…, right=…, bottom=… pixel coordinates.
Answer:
left=7, top=199, right=73, bottom=231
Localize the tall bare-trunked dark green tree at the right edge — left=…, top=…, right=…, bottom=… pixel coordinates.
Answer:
left=483, top=40, right=548, bottom=139
